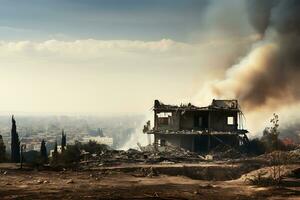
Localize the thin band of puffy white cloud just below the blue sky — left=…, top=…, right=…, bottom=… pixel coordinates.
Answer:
left=0, top=39, right=192, bottom=58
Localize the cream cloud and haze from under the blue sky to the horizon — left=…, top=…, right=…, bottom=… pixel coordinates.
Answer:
left=0, top=38, right=258, bottom=113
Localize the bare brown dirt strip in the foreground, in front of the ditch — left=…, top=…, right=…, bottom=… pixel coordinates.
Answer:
left=0, top=165, right=300, bottom=200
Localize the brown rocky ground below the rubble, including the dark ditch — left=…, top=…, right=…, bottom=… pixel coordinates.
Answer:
left=0, top=162, right=300, bottom=200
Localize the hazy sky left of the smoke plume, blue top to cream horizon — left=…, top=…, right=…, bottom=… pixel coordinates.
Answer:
left=0, top=0, right=256, bottom=114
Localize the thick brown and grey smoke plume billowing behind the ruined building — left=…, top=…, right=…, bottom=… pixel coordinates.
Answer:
left=193, top=0, right=300, bottom=137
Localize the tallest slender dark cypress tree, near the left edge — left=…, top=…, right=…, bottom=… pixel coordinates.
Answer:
left=11, top=116, right=20, bottom=163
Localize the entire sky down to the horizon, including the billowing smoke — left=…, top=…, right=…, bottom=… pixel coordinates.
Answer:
left=0, top=0, right=300, bottom=139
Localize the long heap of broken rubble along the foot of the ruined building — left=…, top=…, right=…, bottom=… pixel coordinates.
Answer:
left=74, top=143, right=300, bottom=169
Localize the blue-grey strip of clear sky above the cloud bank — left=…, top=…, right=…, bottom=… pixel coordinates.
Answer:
left=0, top=0, right=208, bottom=41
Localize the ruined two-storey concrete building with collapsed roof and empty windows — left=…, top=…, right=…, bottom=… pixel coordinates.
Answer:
left=147, top=99, right=248, bottom=152
